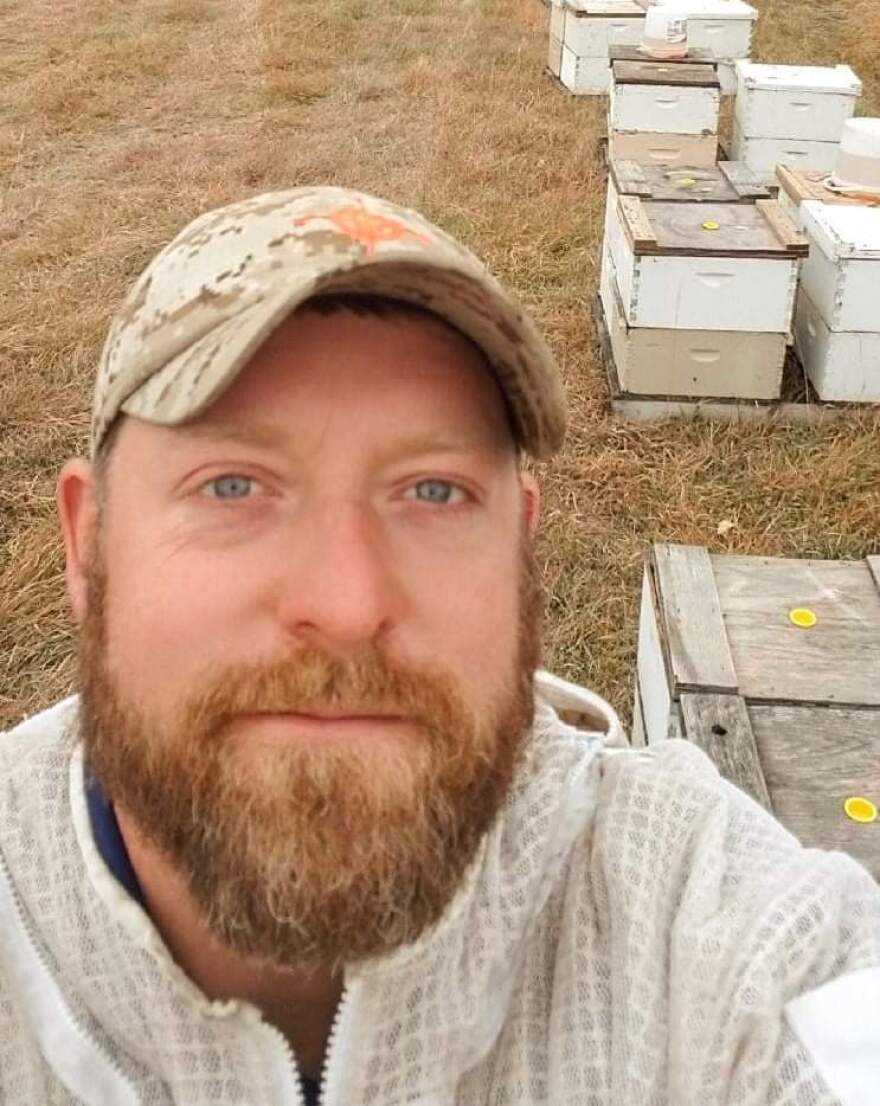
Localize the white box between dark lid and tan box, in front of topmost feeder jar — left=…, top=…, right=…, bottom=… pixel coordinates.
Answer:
left=608, top=73, right=721, bottom=135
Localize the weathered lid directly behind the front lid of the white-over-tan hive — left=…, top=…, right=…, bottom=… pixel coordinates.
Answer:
left=608, top=158, right=771, bottom=204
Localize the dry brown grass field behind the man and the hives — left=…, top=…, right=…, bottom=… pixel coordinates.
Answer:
left=0, top=0, right=880, bottom=726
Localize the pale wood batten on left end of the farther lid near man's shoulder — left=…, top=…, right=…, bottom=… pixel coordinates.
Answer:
left=652, top=544, right=738, bottom=697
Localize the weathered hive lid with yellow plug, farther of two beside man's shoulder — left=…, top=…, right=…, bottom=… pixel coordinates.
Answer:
left=651, top=544, right=880, bottom=707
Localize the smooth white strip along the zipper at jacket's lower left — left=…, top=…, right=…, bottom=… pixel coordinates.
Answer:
left=0, top=852, right=142, bottom=1106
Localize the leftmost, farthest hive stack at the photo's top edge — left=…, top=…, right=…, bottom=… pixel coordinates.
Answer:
left=548, top=0, right=645, bottom=95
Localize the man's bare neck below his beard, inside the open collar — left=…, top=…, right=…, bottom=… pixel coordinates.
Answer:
left=115, top=806, right=342, bottom=1078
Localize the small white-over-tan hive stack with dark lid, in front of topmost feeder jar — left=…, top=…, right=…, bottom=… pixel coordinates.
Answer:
left=608, top=59, right=721, bottom=166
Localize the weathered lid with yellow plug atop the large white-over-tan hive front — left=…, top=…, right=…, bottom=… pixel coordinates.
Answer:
left=618, top=196, right=809, bottom=260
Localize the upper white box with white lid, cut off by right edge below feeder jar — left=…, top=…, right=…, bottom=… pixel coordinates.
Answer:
left=800, top=200, right=880, bottom=333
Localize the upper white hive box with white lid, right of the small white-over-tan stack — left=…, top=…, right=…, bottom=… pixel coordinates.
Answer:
left=734, top=61, right=861, bottom=143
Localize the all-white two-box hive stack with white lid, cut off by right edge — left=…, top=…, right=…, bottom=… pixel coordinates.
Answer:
left=795, top=199, right=880, bottom=403
